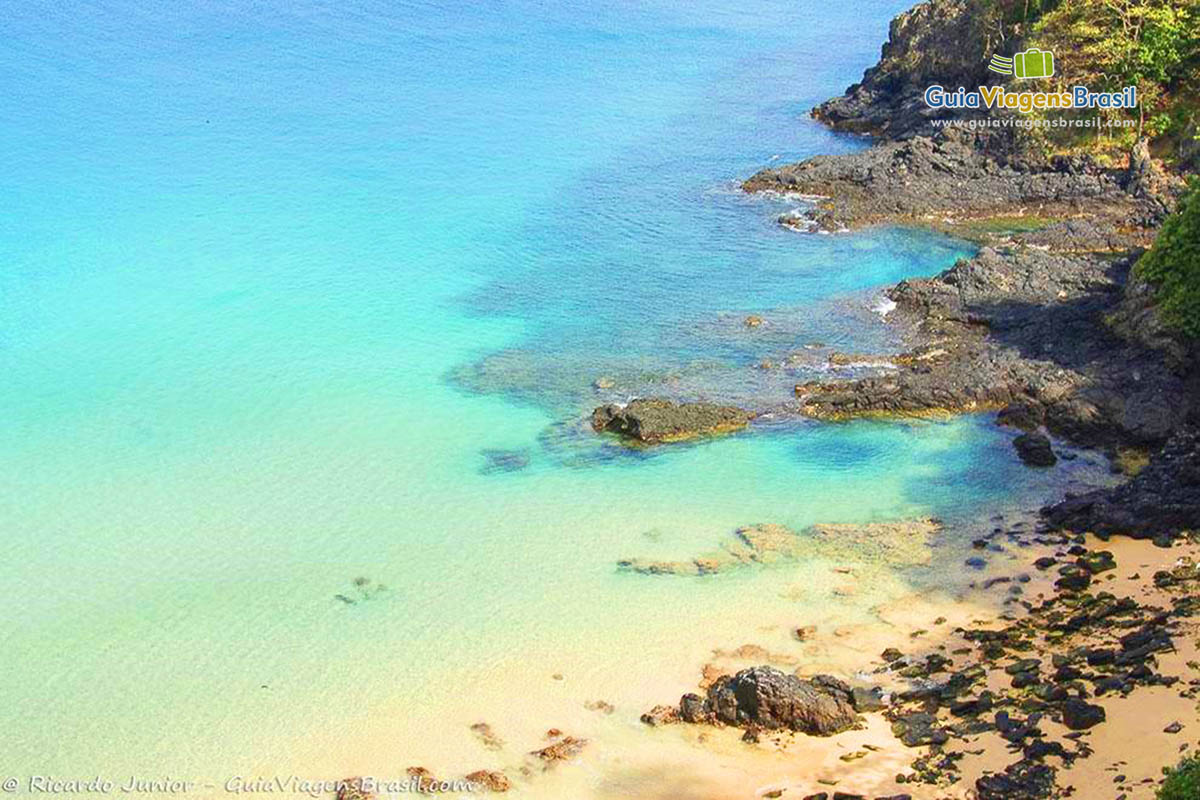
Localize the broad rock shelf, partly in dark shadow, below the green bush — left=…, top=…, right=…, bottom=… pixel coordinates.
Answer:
left=796, top=247, right=1193, bottom=447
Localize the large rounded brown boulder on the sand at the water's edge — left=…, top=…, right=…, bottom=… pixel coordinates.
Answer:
left=679, top=667, right=860, bottom=736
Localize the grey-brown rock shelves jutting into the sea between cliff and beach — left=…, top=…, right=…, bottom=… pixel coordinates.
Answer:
left=593, top=132, right=1200, bottom=450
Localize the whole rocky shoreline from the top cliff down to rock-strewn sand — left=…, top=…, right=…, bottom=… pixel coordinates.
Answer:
left=594, top=2, right=1200, bottom=800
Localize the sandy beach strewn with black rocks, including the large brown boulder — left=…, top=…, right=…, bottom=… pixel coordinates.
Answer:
left=642, top=527, right=1200, bottom=800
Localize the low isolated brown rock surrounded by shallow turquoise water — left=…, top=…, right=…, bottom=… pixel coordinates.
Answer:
left=592, top=398, right=751, bottom=444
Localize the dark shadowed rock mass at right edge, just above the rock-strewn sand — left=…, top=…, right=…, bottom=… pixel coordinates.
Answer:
left=1043, top=426, right=1200, bottom=539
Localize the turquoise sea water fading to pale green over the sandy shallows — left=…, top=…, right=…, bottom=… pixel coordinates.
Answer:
left=0, top=0, right=1113, bottom=786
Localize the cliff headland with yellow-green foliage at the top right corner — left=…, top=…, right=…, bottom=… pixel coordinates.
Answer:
left=814, top=0, right=1200, bottom=158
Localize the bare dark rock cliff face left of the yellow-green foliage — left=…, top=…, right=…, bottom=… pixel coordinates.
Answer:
left=812, top=0, right=1014, bottom=138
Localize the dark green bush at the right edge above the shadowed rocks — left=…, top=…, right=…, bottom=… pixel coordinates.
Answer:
left=1134, top=180, right=1200, bottom=335
